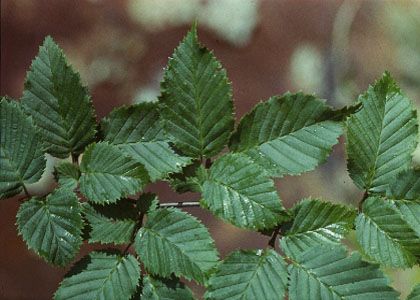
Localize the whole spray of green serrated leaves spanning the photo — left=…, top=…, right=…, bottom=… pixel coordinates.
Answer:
left=0, top=27, right=420, bottom=300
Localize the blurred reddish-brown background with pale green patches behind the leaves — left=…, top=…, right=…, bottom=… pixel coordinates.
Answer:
left=0, top=0, right=420, bottom=299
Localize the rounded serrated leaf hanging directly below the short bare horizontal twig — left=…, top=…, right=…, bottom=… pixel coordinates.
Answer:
left=135, top=208, right=218, bottom=283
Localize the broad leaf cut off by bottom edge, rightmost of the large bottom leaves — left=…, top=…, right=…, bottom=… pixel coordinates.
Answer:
left=289, top=245, right=399, bottom=300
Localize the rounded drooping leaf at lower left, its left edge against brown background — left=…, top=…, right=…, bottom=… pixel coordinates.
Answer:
left=17, top=188, right=83, bottom=266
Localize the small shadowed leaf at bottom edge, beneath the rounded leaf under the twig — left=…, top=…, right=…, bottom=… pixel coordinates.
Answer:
left=141, top=275, right=194, bottom=300
